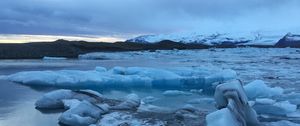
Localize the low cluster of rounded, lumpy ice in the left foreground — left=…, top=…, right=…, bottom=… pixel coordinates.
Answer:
left=35, top=90, right=141, bottom=126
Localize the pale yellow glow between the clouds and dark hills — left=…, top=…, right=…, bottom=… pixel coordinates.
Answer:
left=0, top=34, right=125, bottom=43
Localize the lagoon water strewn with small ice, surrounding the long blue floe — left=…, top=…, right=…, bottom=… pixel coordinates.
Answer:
left=0, top=48, right=300, bottom=126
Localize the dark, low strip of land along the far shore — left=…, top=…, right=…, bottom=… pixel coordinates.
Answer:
left=0, top=40, right=299, bottom=59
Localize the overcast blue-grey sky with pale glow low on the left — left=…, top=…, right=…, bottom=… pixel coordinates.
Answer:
left=0, top=0, right=300, bottom=42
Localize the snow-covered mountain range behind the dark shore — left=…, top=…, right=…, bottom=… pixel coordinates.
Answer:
left=127, top=32, right=285, bottom=45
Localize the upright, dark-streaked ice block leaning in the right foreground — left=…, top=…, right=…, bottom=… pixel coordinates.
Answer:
left=206, top=80, right=259, bottom=126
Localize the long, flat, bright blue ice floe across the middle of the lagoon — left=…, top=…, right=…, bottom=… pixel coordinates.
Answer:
left=1, top=67, right=237, bottom=88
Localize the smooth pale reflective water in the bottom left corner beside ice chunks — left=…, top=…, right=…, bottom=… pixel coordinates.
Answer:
left=0, top=81, right=58, bottom=126
